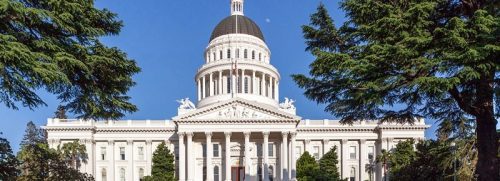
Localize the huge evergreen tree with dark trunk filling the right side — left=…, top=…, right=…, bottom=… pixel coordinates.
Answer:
left=293, top=0, right=500, bottom=180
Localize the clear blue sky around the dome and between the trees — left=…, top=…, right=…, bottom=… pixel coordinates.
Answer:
left=0, top=0, right=435, bottom=151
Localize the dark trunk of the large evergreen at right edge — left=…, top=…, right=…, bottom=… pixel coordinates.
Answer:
left=476, top=114, right=500, bottom=181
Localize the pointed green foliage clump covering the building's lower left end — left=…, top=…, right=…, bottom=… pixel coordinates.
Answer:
left=17, top=122, right=94, bottom=181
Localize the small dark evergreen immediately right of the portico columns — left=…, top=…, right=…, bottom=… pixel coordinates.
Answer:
left=296, top=151, right=319, bottom=181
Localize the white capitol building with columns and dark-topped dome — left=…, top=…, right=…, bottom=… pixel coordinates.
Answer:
left=43, top=0, right=429, bottom=181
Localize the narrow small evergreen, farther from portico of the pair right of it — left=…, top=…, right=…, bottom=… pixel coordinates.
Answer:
left=316, top=146, right=342, bottom=181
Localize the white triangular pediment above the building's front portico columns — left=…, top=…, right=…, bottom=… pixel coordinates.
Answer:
left=173, top=98, right=301, bottom=120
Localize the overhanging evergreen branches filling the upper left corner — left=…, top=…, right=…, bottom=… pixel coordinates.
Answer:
left=0, top=0, right=140, bottom=119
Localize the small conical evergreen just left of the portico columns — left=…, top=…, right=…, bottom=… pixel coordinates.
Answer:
left=144, top=143, right=175, bottom=181
